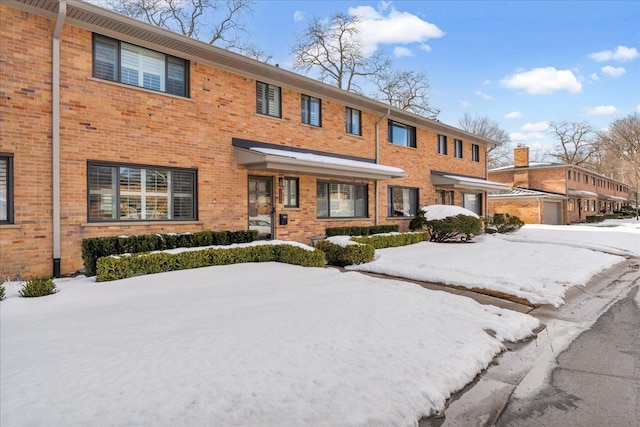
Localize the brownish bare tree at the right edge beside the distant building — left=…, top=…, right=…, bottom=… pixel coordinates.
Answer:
left=598, top=113, right=640, bottom=218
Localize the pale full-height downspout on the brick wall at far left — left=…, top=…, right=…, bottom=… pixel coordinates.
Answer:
left=51, top=0, right=67, bottom=277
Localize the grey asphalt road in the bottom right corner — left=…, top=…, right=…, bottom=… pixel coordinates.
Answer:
left=495, top=286, right=640, bottom=427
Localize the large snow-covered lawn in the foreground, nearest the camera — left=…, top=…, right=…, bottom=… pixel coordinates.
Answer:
left=0, top=263, right=538, bottom=426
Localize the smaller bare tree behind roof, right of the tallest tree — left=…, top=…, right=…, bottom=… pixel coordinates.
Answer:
left=372, top=70, right=440, bottom=118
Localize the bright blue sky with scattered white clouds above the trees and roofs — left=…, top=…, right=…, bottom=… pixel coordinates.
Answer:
left=247, top=0, right=640, bottom=157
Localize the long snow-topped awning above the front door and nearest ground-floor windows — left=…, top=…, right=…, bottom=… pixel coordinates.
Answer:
left=233, top=139, right=407, bottom=180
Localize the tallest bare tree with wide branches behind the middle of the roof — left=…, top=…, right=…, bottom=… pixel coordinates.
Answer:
left=291, top=13, right=391, bottom=93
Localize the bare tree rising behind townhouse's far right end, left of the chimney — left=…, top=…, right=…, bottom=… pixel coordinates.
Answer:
left=458, top=113, right=513, bottom=169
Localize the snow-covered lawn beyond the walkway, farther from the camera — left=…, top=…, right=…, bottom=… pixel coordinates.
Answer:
left=348, top=222, right=640, bottom=307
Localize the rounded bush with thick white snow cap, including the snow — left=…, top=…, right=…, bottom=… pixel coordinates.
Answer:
left=409, top=205, right=482, bottom=242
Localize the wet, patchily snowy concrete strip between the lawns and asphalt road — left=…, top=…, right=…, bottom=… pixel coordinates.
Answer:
left=419, top=258, right=640, bottom=427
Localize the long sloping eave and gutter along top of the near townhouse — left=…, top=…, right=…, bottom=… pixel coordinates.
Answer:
left=2, top=0, right=502, bottom=146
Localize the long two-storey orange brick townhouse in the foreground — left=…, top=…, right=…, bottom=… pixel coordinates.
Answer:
left=0, top=0, right=502, bottom=277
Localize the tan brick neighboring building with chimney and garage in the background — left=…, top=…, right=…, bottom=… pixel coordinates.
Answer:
left=488, top=146, right=629, bottom=224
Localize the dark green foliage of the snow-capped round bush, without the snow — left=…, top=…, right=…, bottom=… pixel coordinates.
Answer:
left=409, top=212, right=482, bottom=242
